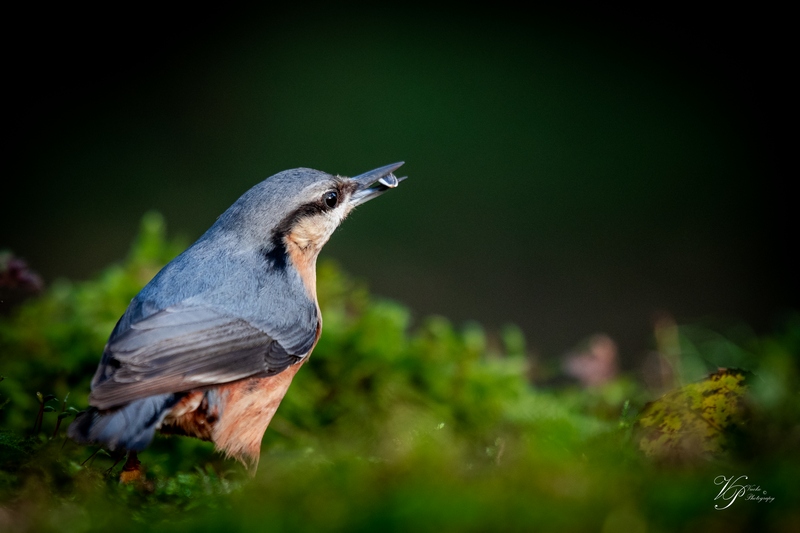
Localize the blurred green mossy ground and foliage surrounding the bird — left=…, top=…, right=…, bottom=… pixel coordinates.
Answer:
left=0, top=213, right=800, bottom=531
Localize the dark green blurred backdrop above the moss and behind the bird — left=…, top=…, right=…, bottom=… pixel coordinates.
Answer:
left=0, top=8, right=798, bottom=364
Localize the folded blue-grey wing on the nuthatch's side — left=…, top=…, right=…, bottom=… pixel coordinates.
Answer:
left=89, top=305, right=317, bottom=409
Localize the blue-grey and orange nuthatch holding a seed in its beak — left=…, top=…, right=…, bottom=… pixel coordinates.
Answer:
left=67, top=162, right=406, bottom=474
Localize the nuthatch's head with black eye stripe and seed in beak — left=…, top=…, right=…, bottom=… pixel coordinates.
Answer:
left=212, top=162, right=405, bottom=267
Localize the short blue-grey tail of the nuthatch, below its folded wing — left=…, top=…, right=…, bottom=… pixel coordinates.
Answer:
left=67, top=394, right=180, bottom=452
